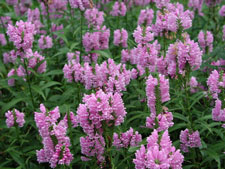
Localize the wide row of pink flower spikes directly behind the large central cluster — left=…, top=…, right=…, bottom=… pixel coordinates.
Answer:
left=63, top=59, right=136, bottom=92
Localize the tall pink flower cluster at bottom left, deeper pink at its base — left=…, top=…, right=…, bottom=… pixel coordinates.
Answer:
left=34, top=104, right=73, bottom=168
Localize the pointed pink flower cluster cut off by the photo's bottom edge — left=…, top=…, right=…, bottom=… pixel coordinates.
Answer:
left=133, top=130, right=184, bottom=169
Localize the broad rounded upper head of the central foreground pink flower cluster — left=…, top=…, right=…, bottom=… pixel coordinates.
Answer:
left=77, top=90, right=127, bottom=135
